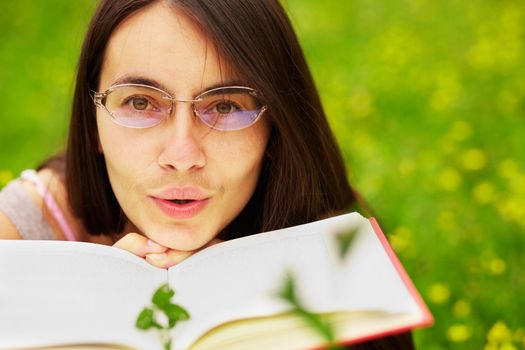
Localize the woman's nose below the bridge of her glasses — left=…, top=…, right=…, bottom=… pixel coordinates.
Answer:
left=158, top=102, right=206, bottom=171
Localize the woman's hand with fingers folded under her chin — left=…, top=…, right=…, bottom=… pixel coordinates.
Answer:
left=113, top=232, right=221, bottom=269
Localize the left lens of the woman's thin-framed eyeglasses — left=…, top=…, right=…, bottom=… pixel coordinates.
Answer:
left=105, top=85, right=171, bottom=128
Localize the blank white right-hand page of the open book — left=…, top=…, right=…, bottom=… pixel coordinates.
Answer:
left=169, top=213, right=413, bottom=349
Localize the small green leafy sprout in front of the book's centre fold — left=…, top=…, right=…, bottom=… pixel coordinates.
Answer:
left=135, top=283, right=190, bottom=350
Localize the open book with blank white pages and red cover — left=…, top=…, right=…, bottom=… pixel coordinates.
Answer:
left=0, top=213, right=433, bottom=350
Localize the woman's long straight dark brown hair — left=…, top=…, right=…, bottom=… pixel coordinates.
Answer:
left=66, top=0, right=355, bottom=239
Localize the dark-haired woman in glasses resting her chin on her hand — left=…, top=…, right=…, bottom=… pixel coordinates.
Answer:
left=0, top=0, right=412, bottom=349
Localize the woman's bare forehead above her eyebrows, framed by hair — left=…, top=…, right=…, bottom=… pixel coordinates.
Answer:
left=99, top=2, right=234, bottom=93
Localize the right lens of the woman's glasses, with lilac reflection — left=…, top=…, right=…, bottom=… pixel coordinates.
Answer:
left=195, top=87, right=263, bottom=131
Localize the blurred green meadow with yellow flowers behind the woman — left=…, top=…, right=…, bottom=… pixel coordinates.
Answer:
left=0, top=0, right=525, bottom=350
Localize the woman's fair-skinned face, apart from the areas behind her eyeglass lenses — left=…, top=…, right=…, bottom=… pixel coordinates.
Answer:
left=97, top=2, right=269, bottom=250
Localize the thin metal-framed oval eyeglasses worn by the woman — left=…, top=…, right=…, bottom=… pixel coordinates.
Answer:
left=93, top=84, right=267, bottom=131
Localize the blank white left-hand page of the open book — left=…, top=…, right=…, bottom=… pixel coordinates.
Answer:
left=0, top=241, right=167, bottom=349
